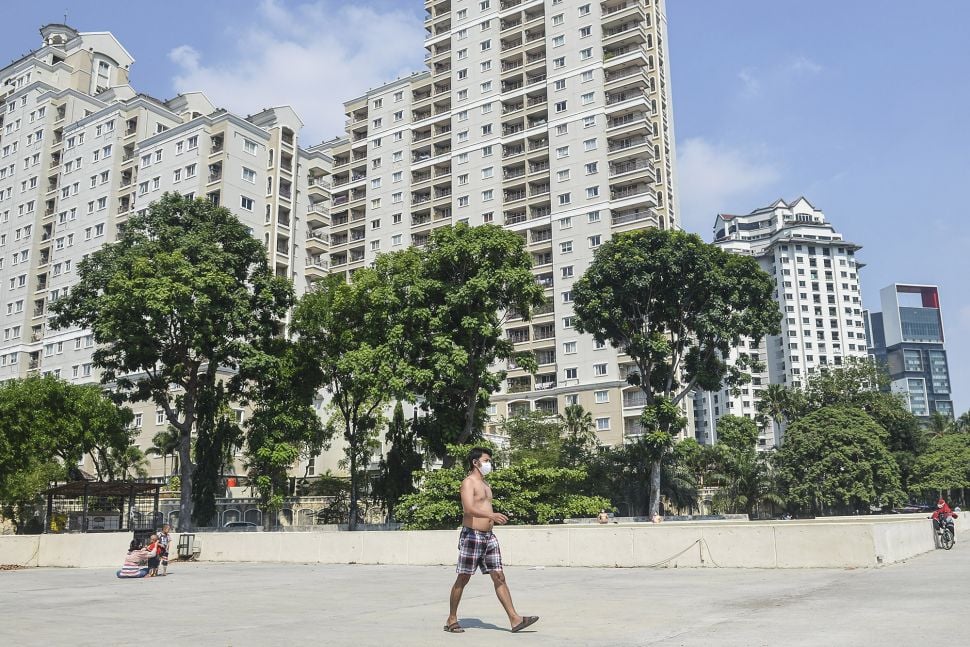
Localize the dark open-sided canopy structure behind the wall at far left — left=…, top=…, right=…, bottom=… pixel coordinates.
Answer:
left=44, top=481, right=161, bottom=533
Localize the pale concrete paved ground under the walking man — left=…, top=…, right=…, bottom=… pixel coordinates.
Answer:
left=0, top=544, right=970, bottom=647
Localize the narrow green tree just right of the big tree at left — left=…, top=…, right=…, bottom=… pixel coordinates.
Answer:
left=240, top=337, right=332, bottom=528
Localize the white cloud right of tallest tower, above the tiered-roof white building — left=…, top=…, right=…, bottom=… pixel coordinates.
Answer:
left=677, top=137, right=780, bottom=235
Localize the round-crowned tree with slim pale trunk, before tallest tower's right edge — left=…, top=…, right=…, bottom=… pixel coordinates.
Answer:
left=573, top=229, right=781, bottom=515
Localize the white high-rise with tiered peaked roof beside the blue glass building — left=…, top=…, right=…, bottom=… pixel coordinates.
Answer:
left=694, top=198, right=867, bottom=449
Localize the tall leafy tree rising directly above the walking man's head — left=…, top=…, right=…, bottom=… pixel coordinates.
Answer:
left=376, top=224, right=545, bottom=465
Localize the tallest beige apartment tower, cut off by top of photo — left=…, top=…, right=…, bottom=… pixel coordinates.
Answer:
left=319, top=0, right=678, bottom=444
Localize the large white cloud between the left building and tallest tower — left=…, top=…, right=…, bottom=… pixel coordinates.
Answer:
left=169, top=0, right=424, bottom=144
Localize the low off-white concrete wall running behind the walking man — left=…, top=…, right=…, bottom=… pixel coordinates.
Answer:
left=0, top=515, right=970, bottom=568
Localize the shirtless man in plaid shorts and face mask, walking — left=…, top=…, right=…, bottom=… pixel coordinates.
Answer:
left=445, top=447, right=539, bottom=633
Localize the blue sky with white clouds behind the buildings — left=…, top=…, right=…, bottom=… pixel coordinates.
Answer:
left=4, top=0, right=970, bottom=412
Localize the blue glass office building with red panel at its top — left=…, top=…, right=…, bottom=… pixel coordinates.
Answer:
left=865, top=283, right=954, bottom=419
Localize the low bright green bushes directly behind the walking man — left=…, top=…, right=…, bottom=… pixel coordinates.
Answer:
left=398, top=446, right=610, bottom=530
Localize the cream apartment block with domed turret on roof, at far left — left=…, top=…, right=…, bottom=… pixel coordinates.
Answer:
left=0, top=25, right=330, bottom=473
